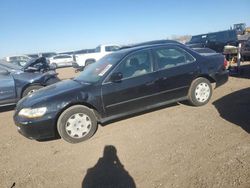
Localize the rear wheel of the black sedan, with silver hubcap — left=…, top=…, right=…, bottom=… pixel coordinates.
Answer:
left=188, top=78, right=213, bottom=106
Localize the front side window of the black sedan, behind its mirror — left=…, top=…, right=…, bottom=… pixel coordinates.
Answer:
left=115, top=51, right=152, bottom=79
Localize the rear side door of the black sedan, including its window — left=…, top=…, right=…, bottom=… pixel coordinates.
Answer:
left=153, top=46, right=199, bottom=102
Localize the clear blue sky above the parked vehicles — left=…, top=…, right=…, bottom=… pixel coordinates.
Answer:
left=0, top=0, right=250, bottom=57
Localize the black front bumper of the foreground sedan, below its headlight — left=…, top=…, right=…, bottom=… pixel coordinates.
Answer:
left=14, top=115, right=57, bottom=140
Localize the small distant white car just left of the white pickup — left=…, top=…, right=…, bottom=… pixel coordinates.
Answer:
left=48, top=54, right=74, bottom=68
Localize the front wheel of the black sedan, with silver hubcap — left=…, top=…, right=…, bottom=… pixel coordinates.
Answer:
left=57, top=105, right=97, bottom=143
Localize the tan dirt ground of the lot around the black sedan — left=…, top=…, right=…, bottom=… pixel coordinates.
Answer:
left=0, top=65, right=250, bottom=188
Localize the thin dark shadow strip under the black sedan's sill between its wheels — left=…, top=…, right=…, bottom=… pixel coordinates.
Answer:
left=100, top=102, right=179, bottom=127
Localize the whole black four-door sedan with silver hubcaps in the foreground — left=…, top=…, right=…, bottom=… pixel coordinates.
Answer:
left=14, top=41, right=228, bottom=143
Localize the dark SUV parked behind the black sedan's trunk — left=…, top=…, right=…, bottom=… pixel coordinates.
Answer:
left=186, top=30, right=238, bottom=53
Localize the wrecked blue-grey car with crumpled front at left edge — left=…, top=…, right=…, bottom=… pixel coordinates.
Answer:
left=0, top=58, right=59, bottom=106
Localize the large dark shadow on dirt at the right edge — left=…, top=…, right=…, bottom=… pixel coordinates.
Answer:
left=213, top=87, right=250, bottom=133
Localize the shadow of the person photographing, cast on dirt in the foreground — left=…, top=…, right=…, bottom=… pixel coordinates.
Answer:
left=82, top=145, right=136, bottom=188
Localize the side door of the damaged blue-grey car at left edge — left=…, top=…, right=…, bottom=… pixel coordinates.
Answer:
left=0, top=67, right=16, bottom=105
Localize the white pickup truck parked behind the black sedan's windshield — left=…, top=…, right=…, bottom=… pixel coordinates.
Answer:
left=75, top=45, right=120, bottom=68
